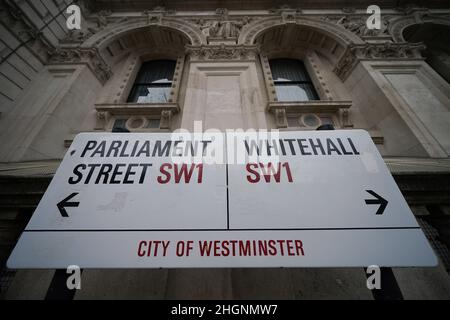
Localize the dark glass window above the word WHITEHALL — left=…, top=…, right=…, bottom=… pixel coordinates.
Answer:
left=269, top=59, right=319, bottom=101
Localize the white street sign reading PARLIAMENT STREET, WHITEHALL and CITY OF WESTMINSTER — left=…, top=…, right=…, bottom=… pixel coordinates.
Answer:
left=8, top=130, right=437, bottom=268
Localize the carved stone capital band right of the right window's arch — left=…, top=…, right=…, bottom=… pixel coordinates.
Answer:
left=334, top=42, right=425, bottom=80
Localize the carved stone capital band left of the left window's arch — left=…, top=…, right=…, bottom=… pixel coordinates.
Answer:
left=49, top=48, right=112, bottom=83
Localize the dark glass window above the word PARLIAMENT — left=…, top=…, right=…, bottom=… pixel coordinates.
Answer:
left=128, top=60, right=176, bottom=103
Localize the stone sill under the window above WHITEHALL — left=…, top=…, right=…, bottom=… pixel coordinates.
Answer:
left=267, top=100, right=352, bottom=113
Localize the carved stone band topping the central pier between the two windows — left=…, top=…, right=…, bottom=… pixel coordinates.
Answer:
left=186, top=44, right=258, bottom=60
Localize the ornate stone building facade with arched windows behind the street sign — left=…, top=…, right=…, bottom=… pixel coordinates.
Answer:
left=0, top=0, right=450, bottom=299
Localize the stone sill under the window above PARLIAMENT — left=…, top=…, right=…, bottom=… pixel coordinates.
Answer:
left=95, top=103, right=180, bottom=116
